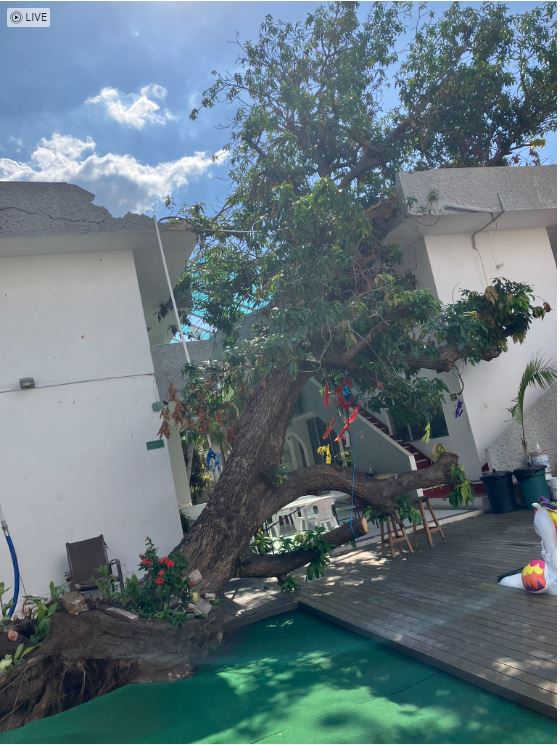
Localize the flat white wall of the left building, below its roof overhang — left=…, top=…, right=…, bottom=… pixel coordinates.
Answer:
left=0, top=250, right=181, bottom=593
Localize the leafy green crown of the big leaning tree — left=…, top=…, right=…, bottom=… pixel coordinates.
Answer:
left=166, top=3, right=556, bottom=436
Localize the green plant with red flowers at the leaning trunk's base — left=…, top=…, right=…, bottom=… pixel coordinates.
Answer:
left=97, top=538, right=192, bottom=626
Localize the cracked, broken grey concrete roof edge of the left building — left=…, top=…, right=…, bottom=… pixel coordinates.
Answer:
left=0, top=181, right=190, bottom=238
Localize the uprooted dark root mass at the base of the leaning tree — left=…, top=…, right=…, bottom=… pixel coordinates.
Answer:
left=0, top=607, right=224, bottom=732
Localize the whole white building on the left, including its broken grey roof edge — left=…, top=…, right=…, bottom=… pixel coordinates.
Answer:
left=0, top=183, right=195, bottom=599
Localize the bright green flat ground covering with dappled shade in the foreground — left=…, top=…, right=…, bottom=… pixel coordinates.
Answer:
left=0, top=612, right=556, bottom=743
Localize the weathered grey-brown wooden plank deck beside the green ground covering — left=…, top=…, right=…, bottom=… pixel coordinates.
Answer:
left=223, top=511, right=556, bottom=717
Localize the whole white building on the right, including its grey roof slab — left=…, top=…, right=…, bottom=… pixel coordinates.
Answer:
left=388, top=166, right=557, bottom=478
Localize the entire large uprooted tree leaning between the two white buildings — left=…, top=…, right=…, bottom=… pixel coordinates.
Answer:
left=0, top=3, right=555, bottom=729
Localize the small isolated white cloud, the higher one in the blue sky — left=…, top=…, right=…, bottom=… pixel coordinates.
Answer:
left=85, top=83, right=177, bottom=129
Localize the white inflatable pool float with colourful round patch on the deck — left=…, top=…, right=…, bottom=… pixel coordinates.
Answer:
left=498, top=502, right=557, bottom=595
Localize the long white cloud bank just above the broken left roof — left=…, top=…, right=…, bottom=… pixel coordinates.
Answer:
left=0, top=132, right=227, bottom=215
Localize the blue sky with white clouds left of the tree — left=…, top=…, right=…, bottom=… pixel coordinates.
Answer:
left=0, top=0, right=556, bottom=215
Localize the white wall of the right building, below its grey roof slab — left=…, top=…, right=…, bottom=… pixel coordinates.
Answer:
left=425, top=222, right=557, bottom=464
